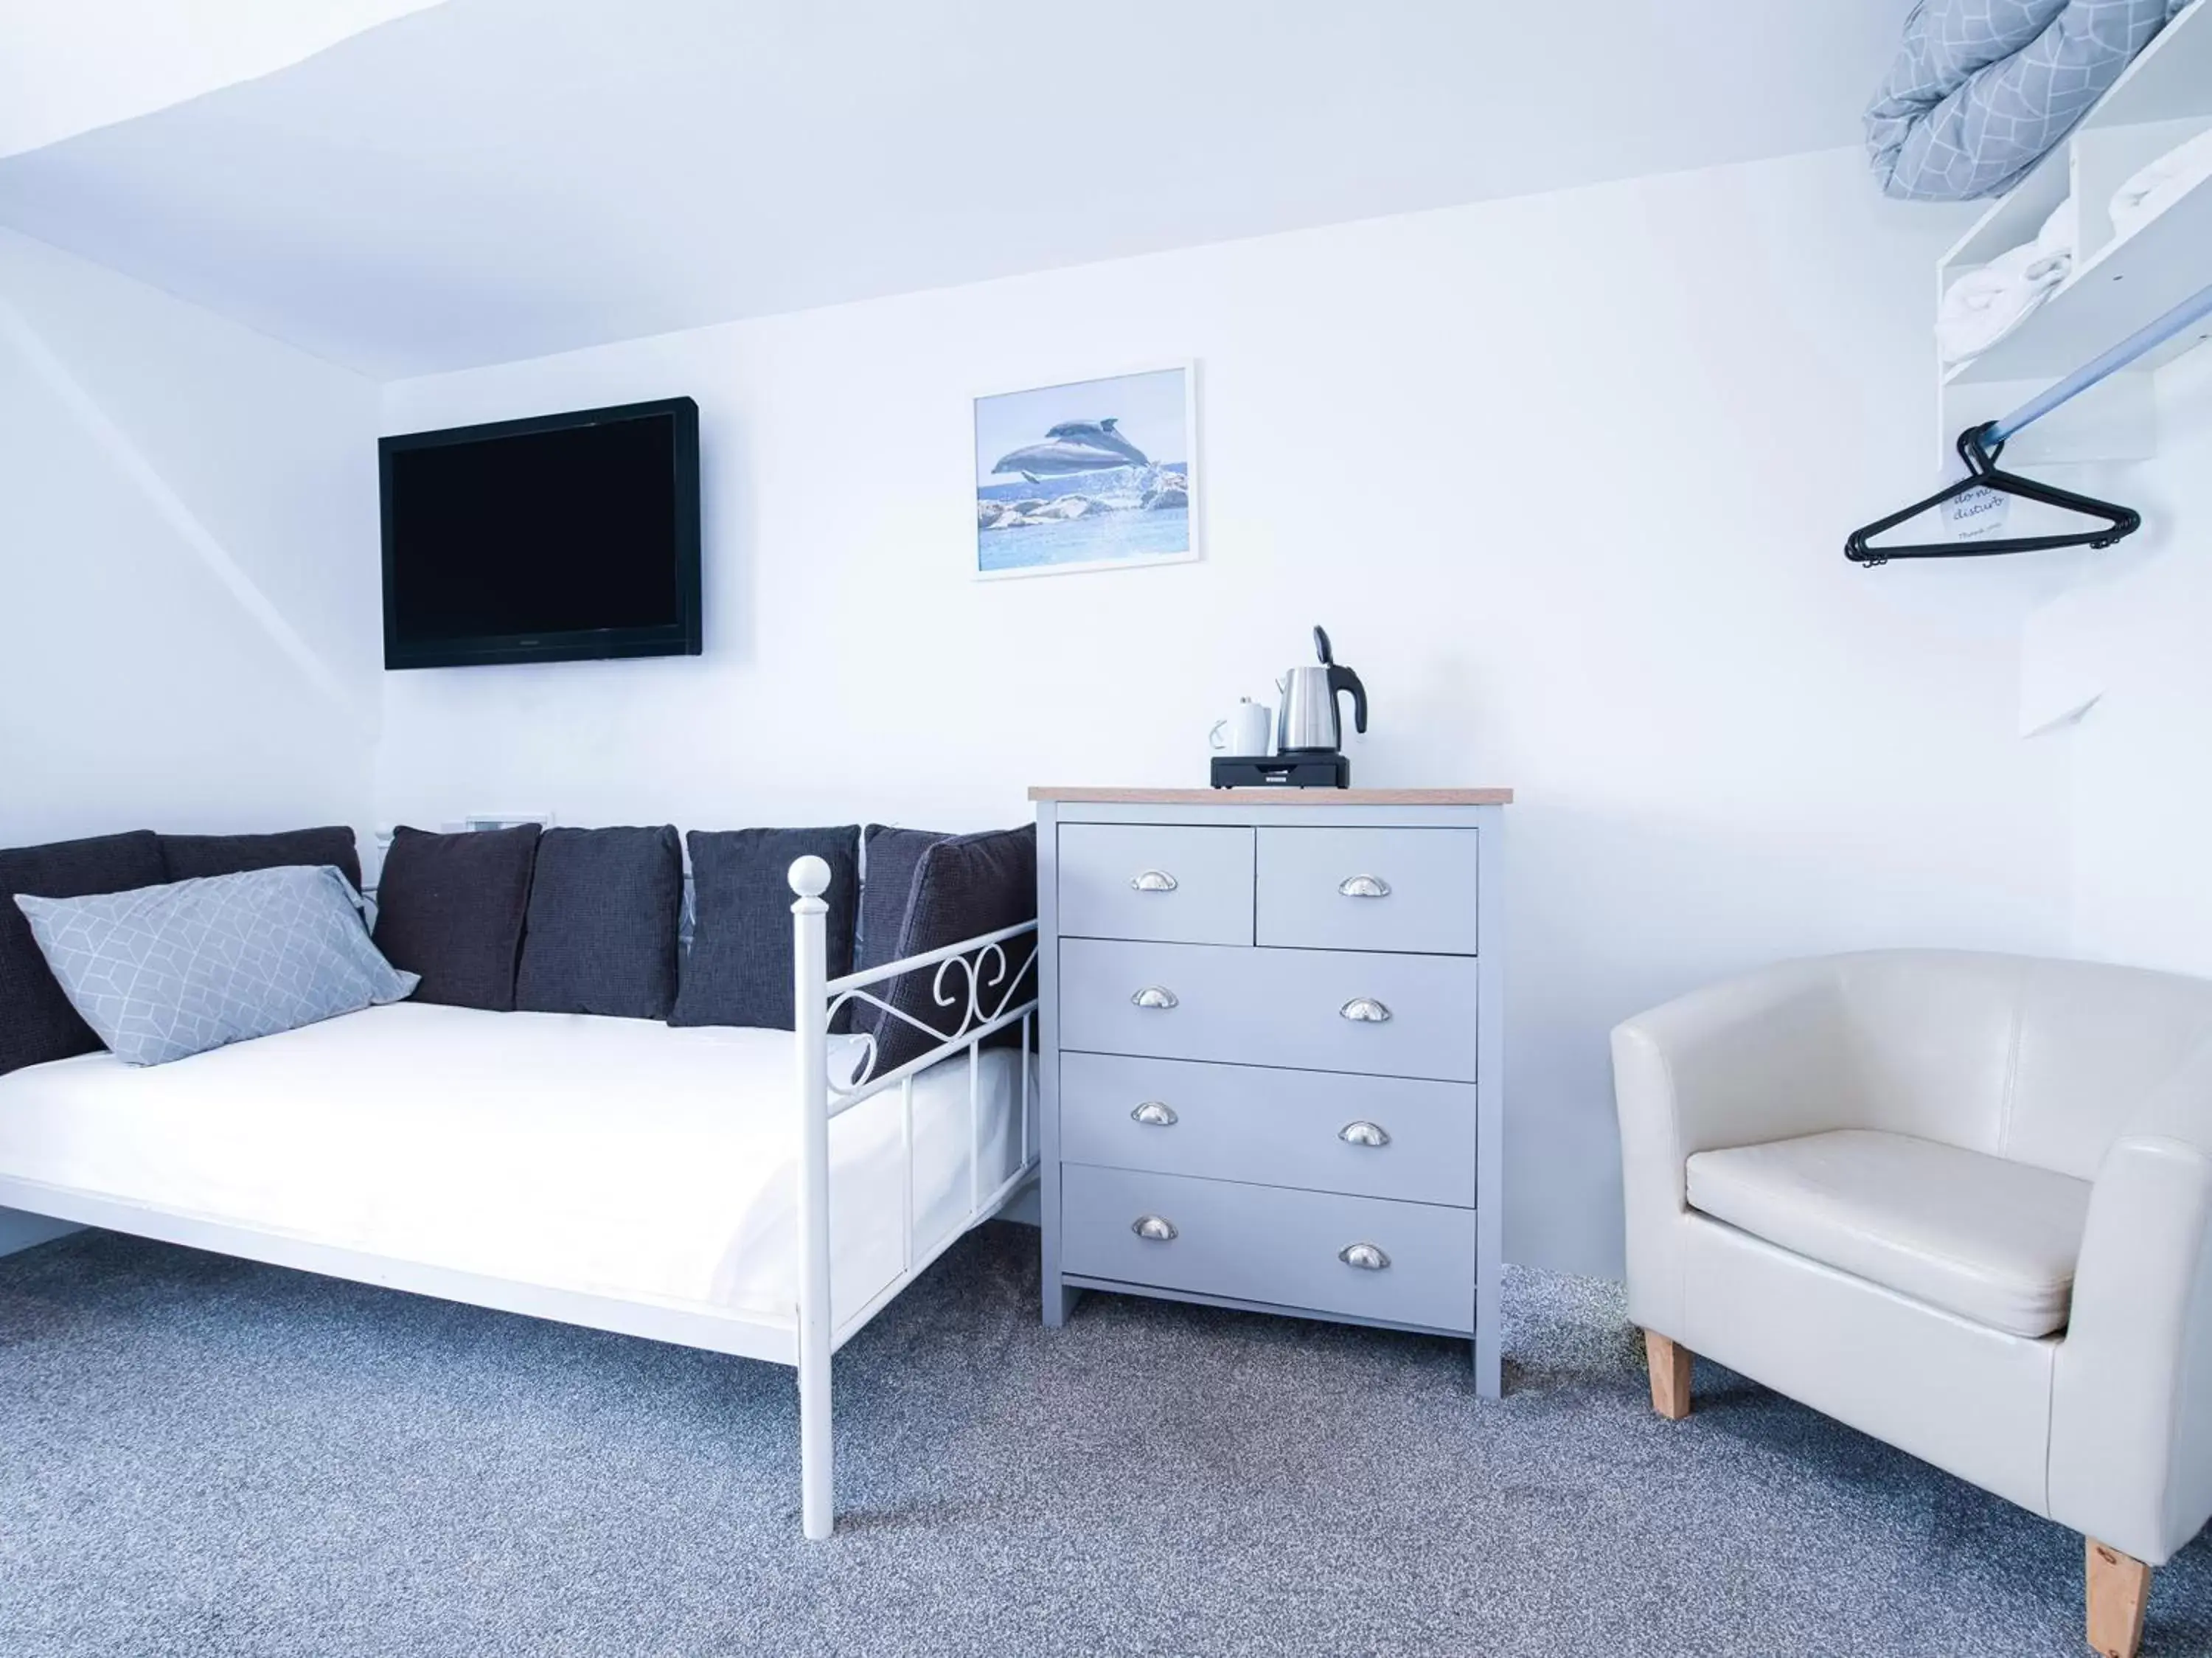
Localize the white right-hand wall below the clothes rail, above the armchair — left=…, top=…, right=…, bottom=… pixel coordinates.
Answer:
left=2026, top=350, right=2212, bottom=974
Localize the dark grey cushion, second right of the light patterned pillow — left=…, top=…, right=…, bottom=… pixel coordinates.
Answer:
left=515, top=823, right=684, bottom=1019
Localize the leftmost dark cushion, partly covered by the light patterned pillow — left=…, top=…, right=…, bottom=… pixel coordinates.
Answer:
left=0, top=830, right=168, bottom=1076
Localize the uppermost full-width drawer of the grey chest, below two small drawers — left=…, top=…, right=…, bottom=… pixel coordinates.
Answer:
left=1060, top=939, right=1478, bottom=1083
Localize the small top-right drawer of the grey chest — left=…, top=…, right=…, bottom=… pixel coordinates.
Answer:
left=1256, top=828, right=1478, bottom=957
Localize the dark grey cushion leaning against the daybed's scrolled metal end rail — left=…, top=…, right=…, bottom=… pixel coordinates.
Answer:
left=856, top=823, right=1037, bottom=1076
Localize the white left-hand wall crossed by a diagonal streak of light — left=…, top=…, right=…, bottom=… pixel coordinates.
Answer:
left=0, top=232, right=383, bottom=846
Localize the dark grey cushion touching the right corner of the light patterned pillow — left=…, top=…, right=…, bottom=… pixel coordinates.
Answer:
left=376, top=823, right=538, bottom=1014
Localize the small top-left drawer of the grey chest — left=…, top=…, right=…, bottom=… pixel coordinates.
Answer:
left=1060, top=823, right=1252, bottom=946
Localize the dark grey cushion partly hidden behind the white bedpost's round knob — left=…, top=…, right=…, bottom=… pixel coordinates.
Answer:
left=668, top=823, right=860, bottom=1032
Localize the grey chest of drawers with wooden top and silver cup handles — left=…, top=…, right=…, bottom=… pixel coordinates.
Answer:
left=1031, top=788, right=1511, bottom=1397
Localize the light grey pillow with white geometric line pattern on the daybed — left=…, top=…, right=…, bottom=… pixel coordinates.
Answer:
left=15, top=866, right=418, bottom=1065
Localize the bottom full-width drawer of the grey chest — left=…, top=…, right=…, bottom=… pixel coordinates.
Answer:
left=1060, top=1165, right=1475, bottom=1335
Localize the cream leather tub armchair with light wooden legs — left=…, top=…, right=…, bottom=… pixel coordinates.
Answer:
left=1613, top=950, right=2212, bottom=1658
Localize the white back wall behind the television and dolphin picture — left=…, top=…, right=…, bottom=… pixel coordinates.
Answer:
left=376, top=150, right=2066, bottom=1271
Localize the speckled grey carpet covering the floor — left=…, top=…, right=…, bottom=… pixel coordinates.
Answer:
left=0, top=1227, right=2212, bottom=1658
